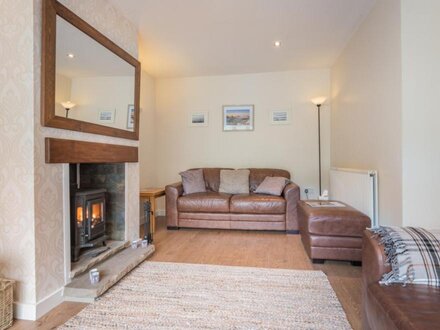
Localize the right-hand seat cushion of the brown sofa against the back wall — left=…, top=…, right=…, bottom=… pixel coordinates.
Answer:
left=230, top=194, right=286, bottom=214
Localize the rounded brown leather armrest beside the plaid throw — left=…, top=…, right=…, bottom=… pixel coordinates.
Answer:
left=362, top=230, right=391, bottom=286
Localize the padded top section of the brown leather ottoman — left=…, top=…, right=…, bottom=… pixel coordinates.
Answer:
left=298, top=201, right=371, bottom=237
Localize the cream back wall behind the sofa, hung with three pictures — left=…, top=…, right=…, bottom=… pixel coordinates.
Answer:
left=155, top=70, right=330, bottom=208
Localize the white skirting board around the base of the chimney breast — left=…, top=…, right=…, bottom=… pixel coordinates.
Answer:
left=14, top=288, right=64, bottom=321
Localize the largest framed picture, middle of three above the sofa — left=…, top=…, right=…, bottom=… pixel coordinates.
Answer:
left=223, top=105, right=254, bottom=131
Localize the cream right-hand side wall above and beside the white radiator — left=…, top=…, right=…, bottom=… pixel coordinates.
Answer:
left=331, top=0, right=402, bottom=225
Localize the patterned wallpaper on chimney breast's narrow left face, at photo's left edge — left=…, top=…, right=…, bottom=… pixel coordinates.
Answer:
left=0, top=0, right=35, bottom=302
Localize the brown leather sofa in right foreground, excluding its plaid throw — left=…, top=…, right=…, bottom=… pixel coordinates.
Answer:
left=362, top=230, right=440, bottom=330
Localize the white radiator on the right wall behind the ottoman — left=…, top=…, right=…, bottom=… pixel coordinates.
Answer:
left=329, top=168, right=379, bottom=227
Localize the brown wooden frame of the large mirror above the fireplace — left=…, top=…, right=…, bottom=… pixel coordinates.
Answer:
left=41, top=0, right=141, bottom=140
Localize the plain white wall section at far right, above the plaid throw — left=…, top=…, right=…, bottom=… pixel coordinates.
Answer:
left=402, top=0, right=440, bottom=228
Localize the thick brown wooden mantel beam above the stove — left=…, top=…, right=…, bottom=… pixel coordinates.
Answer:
left=45, top=138, right=138, bottom=164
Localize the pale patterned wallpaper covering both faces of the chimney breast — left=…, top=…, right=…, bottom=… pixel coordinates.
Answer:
left=0, top=0, right=139, bottom=304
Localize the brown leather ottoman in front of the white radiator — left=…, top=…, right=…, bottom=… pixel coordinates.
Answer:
left=298, top=200, right=371, bottom=265
